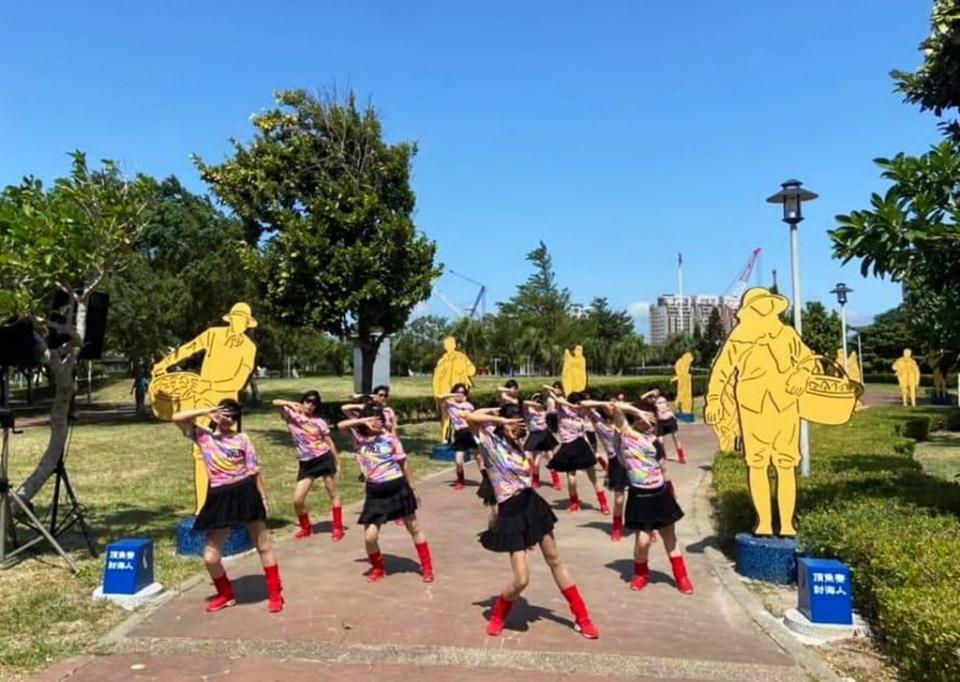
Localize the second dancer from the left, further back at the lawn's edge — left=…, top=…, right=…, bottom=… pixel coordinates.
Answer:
left=273, top=391, right=343, bottom=542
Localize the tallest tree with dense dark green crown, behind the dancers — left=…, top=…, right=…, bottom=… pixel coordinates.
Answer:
left=197, top=90, right=440, bottom=390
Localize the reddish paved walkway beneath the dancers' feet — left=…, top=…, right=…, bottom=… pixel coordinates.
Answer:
left=40, top=426, right=807, bottom=682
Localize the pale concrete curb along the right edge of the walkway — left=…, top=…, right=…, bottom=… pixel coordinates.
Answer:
left=692, top=454, right=844, bottom=682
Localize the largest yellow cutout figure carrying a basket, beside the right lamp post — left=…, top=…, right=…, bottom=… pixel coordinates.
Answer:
left=704, top=287, right=862, bottom=537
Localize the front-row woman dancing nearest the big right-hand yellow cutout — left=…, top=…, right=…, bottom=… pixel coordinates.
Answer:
left=614, top=400, right=693, bottom=594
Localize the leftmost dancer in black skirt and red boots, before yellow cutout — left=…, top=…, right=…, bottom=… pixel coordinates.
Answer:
left=173, top=398, right=283, bottom=613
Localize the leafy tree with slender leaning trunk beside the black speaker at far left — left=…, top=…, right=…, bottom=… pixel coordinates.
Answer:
left=0, top=152, right=147, bottom=499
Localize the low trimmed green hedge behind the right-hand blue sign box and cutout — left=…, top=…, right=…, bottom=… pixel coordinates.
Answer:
left=714, top=407, right=960, bottom=682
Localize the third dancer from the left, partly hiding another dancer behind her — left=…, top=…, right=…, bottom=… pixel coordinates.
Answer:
left=337, top=404, right=433, bottom=583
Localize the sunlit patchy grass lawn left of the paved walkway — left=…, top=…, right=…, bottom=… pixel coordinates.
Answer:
left=0, top=410, right=442, bottom=679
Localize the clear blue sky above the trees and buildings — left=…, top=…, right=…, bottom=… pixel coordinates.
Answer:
left=0, top=0, right=938, bottom=332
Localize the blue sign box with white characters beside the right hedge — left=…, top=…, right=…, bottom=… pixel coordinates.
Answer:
left=797, top=557, right=853, bottom=625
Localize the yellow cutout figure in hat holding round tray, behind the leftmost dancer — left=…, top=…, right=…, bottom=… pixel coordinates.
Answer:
left=150, top=303, right=257, bottom=513
